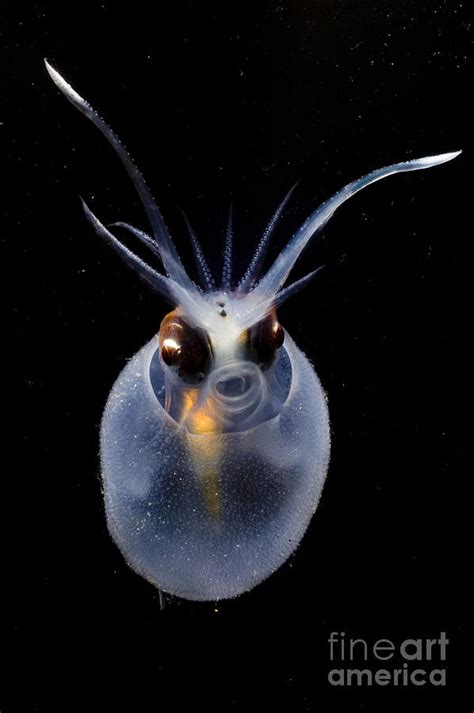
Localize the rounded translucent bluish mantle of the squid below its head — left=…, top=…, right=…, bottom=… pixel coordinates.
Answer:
left=101, top=334, right=330, bottom=600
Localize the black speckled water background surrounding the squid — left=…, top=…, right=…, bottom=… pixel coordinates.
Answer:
left=0, top=0, right=474, bottom=713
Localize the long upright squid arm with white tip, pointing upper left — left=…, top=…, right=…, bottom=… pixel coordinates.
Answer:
left=44, top=59, right=197, bottom=291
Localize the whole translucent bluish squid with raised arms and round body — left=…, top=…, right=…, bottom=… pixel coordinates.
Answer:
left=46, top=62, right=460, bottom=600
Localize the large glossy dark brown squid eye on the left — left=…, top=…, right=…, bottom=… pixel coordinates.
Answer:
left=159, top=311, right=211, bottom=385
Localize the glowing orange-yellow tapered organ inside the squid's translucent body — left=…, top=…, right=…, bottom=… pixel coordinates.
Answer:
left=180, top=389, right=222, bottom=527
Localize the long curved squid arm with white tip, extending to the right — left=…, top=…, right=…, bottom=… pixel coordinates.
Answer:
left=254, top=151, right=461, bottom=299
